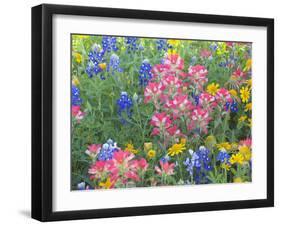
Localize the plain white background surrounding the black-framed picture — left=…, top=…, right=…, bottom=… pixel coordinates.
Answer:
left=0, top=0, right=276, bottom=226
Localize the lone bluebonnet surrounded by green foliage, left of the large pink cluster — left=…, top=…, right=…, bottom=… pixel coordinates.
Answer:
left=116, top=92, right=133, bottom=124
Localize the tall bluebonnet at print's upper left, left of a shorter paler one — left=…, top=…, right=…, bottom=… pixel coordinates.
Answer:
left=86, top=44, right=105, bottom=79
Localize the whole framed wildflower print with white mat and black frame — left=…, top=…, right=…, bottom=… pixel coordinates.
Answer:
left=32, top=4, right=274, bottom=221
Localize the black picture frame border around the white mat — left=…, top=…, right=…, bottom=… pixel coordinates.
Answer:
left=32, top=4, right=274, bottom=221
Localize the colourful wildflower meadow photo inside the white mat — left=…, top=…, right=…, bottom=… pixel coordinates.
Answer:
left=71, top=34, right=252, bottom=190
